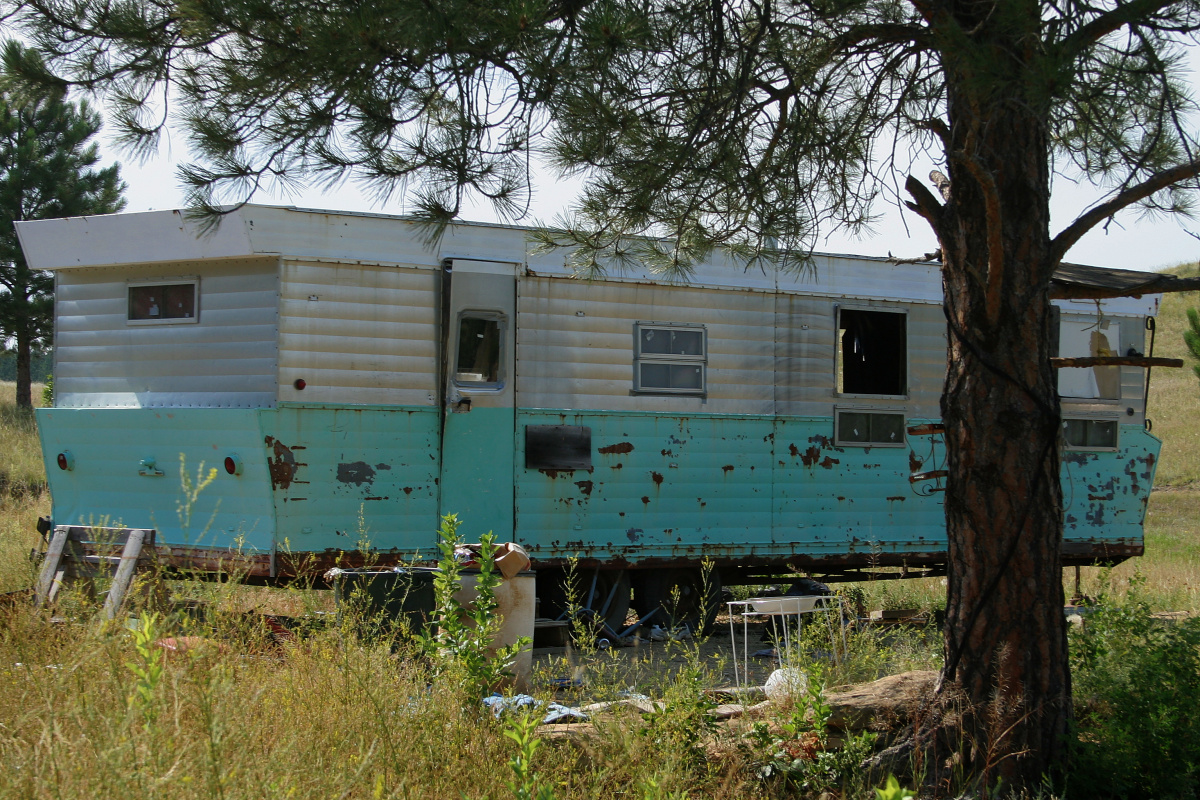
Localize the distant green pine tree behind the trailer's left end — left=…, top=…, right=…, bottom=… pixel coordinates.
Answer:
left=0, top=43, right=125, bottom=408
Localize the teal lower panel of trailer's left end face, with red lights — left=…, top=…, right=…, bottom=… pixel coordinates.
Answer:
left=37, top=408, right=275, bottom=553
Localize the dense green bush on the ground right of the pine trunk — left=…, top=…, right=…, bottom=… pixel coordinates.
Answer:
left=1070, top=578, right=1200, bottom=800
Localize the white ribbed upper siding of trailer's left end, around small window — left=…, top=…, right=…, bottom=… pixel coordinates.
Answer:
left=54, top=258, right=278, bottom=408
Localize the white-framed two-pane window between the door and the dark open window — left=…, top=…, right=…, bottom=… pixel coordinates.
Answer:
left=634, top=323, right=708, bottom=395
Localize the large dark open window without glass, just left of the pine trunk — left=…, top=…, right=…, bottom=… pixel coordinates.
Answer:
left=838, top=308, right=908, bottom=397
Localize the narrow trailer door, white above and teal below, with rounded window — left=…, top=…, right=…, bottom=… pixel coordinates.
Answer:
left=439, top=259, right=518, bottom=541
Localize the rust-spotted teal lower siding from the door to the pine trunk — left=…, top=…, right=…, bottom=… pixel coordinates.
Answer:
left=517, top=411, right=944, bottom=561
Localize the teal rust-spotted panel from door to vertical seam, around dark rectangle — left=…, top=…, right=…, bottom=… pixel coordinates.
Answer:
left=516, top=410, right=773, bottom=563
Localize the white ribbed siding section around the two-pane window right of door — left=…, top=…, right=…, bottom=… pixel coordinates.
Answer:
left=517, top=277, right=775, bottom=414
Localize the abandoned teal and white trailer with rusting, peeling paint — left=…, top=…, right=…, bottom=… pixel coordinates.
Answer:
left=18, top=205, right=1159, bottom=619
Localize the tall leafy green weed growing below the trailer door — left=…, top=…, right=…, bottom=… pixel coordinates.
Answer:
left=422, top=515, right=530, bottom=692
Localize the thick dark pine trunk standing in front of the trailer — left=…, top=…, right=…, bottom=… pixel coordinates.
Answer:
left=937, top=12, right=1070, bottom=788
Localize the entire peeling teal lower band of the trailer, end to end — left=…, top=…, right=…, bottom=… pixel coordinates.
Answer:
left=37, top=405, right=1159, bottom=563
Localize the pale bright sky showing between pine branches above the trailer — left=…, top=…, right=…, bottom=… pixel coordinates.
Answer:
left=101, top=115, right=1200, bottom=271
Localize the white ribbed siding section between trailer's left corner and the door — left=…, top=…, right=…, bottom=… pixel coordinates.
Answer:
left=278, top=260, right=440, bottom=405
